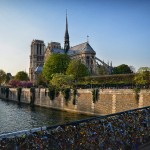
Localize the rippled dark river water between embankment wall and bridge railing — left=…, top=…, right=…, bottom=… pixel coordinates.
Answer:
left=0, top=99, right=93, bottom=134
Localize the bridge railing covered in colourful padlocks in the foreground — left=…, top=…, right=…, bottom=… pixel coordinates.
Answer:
left=0, top=107, right=150, bottom=150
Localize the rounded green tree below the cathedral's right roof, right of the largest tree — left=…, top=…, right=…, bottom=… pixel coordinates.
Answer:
left=66, top=60, right=89, bottom=79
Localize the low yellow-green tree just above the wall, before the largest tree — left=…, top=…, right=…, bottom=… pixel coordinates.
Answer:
left=50, top=74, right=74, bottom=89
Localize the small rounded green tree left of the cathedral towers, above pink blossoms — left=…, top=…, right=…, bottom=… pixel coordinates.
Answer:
left=15, top=71, right=29, bottom=81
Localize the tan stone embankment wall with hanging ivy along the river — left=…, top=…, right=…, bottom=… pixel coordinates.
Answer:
left=0, top=88, right=150, bottom=115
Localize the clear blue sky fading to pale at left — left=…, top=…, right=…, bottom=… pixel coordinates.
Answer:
left=0, top=0, right=150, bottom=75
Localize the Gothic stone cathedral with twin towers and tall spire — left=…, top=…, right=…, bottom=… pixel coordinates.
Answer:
left=29, top=15, right=112, bottom=82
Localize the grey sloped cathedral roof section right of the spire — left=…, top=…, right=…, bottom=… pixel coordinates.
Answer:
left=69, top=42, right=95, bottom=54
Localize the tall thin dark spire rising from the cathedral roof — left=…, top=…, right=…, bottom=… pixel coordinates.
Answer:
left=64, top=11, right=70, bottom=53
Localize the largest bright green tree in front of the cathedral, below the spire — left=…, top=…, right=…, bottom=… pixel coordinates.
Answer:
left=43, top=54, right=70, bottom=81
